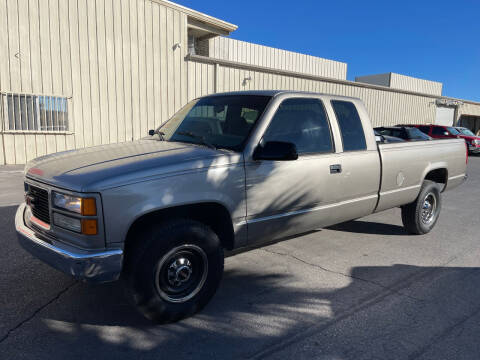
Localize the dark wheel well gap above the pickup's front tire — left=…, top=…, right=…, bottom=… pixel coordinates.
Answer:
left=125, top=203, right=234, bottom=250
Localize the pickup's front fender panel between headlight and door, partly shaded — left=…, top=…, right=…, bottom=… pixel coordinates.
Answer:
left=102, top=164, right=246, bottom=244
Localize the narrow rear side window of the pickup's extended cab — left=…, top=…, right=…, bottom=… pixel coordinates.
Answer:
left=331, top=100, right=367, bottom=151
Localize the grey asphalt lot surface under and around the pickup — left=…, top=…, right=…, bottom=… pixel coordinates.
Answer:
left=0, top=157, right=480, bottom=360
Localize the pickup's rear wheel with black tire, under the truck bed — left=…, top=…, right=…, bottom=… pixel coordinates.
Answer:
left=402, top=180, right=442, bottom=235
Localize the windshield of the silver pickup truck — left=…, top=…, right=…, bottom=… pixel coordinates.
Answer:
left=154, top=95, right=271, bottom=151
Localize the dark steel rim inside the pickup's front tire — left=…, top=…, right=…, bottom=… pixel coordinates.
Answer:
left=155, top=245, right=208, bottom=303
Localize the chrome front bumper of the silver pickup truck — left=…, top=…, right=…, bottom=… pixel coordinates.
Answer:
left=15, top=204, right=123, bottom=282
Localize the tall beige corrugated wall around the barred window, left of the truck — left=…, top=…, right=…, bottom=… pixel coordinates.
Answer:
left=0, top=0, right=187, bottom=164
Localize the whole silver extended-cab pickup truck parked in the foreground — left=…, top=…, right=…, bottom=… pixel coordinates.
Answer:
left=15, top=91, right=468, bottom=322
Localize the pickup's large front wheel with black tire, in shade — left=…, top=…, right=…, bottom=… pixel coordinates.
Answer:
left=125, top=219, right=224, bottom=323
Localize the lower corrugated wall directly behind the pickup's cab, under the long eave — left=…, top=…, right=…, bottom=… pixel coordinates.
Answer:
left=188, top=61, right=435, bottom=126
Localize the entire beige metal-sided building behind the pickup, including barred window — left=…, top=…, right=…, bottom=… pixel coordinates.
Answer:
left=0, top=0, right=480, bottom=164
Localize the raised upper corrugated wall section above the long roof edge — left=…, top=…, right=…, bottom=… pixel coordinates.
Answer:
left=208, top=37, right=347, bottom=80
